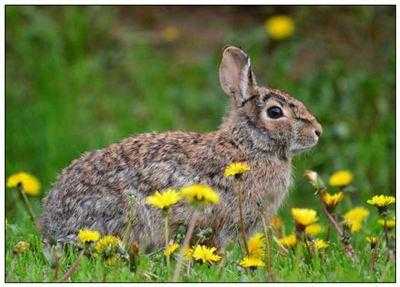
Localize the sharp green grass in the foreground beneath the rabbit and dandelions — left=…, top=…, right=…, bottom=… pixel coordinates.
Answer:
left=6, top=212, right=395, bottom=282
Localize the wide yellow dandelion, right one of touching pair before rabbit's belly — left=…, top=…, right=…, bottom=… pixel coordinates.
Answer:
left=182, top=184, right=219, bottom=204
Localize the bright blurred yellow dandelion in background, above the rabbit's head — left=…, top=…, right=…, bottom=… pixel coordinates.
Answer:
left=265, top=15, right=294, bottom=40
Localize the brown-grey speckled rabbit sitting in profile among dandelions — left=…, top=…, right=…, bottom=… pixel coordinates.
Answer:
left=39, top=46, right=322, bottom=251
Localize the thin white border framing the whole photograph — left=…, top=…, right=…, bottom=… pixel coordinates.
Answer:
left=0, top=0, right=400, bottom=286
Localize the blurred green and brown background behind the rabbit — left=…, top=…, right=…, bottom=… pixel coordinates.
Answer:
left=6, top=6, right=395, bottom=220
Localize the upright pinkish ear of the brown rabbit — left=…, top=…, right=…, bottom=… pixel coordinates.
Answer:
left=219, top=46, right=257, bottom=106
